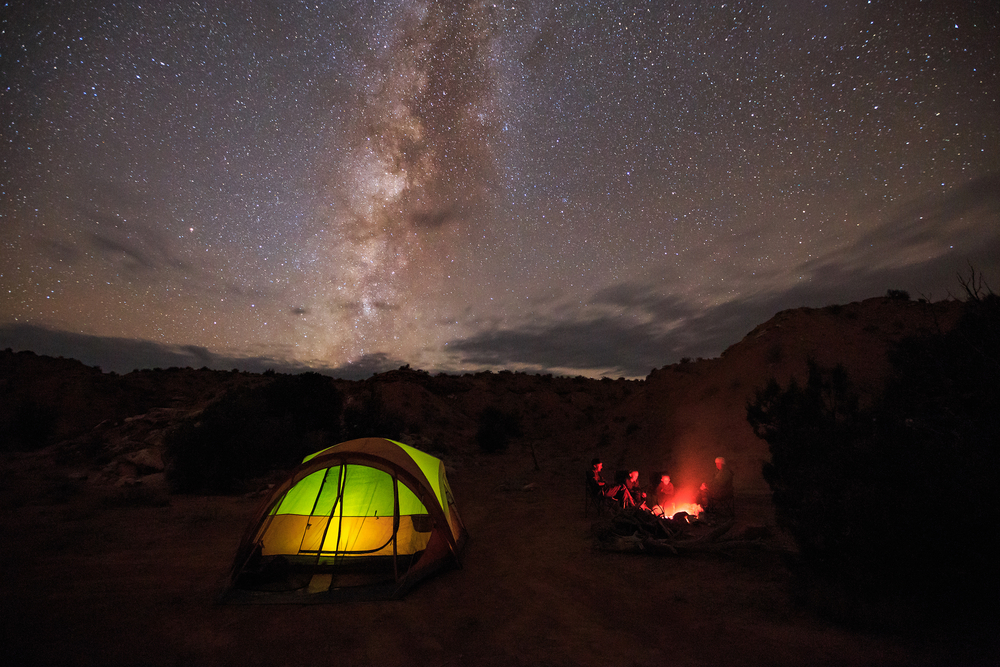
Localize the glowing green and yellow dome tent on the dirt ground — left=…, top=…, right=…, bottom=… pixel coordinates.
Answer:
left=223, top=438, right=466, bottom=602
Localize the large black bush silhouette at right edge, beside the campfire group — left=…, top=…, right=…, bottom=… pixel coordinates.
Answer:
left=747, top=295, right=1000, bottom=618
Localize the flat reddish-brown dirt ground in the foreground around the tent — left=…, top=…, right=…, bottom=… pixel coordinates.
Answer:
left=0, top=453, right=1000, bottom=667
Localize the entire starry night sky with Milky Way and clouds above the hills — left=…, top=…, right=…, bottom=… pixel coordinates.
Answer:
left=0, top=0, right=1000, bottom=377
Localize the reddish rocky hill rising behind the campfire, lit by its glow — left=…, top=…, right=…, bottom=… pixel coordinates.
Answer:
left=628, top=298, right=963, bottom=491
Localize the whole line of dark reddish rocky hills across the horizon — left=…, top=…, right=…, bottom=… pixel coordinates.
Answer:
left=0, top=298, right=962, bottom=504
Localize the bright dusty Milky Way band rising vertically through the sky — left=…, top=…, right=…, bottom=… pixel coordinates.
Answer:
left=299, top=2, right=499, bottom=368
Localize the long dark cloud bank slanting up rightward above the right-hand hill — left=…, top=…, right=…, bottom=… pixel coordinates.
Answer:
left=445, top=175, right=1000, bottom=377
